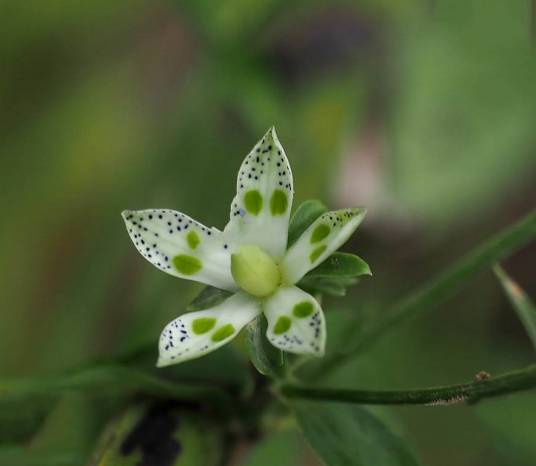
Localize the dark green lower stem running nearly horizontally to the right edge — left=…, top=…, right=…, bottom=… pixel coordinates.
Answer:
left=279, top=365, right=536, bottom=406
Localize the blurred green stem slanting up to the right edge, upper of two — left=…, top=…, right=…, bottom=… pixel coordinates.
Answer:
left=314, top=210, right=536, bottom=376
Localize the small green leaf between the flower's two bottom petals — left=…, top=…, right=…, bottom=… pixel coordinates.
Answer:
left=246, top=314, right=285, bottom=378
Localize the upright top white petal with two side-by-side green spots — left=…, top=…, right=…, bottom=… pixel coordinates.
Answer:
left=224, top=128, right=294, bottom=260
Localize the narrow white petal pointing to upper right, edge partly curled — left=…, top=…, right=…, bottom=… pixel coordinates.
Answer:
left=281, top=208, right=366, bottom=284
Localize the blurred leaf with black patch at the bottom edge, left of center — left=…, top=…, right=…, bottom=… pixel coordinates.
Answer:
left=91, top=402, right=224, bottom=466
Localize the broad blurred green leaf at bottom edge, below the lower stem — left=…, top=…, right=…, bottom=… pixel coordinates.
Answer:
left=295, top=402, right=419, bottom=466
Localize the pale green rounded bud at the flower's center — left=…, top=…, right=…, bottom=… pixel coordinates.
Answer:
left=231, top=245, right=281, bottom=298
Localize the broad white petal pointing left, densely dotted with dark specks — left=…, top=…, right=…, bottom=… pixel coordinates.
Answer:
left=122, top=209, right=237, bottom=291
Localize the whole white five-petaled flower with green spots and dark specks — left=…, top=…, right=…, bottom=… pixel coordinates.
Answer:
left=122, top=128, right=365, bottom=367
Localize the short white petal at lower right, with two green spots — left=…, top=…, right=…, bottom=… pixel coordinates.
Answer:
left=264, top=286, right=326, bottom=356
